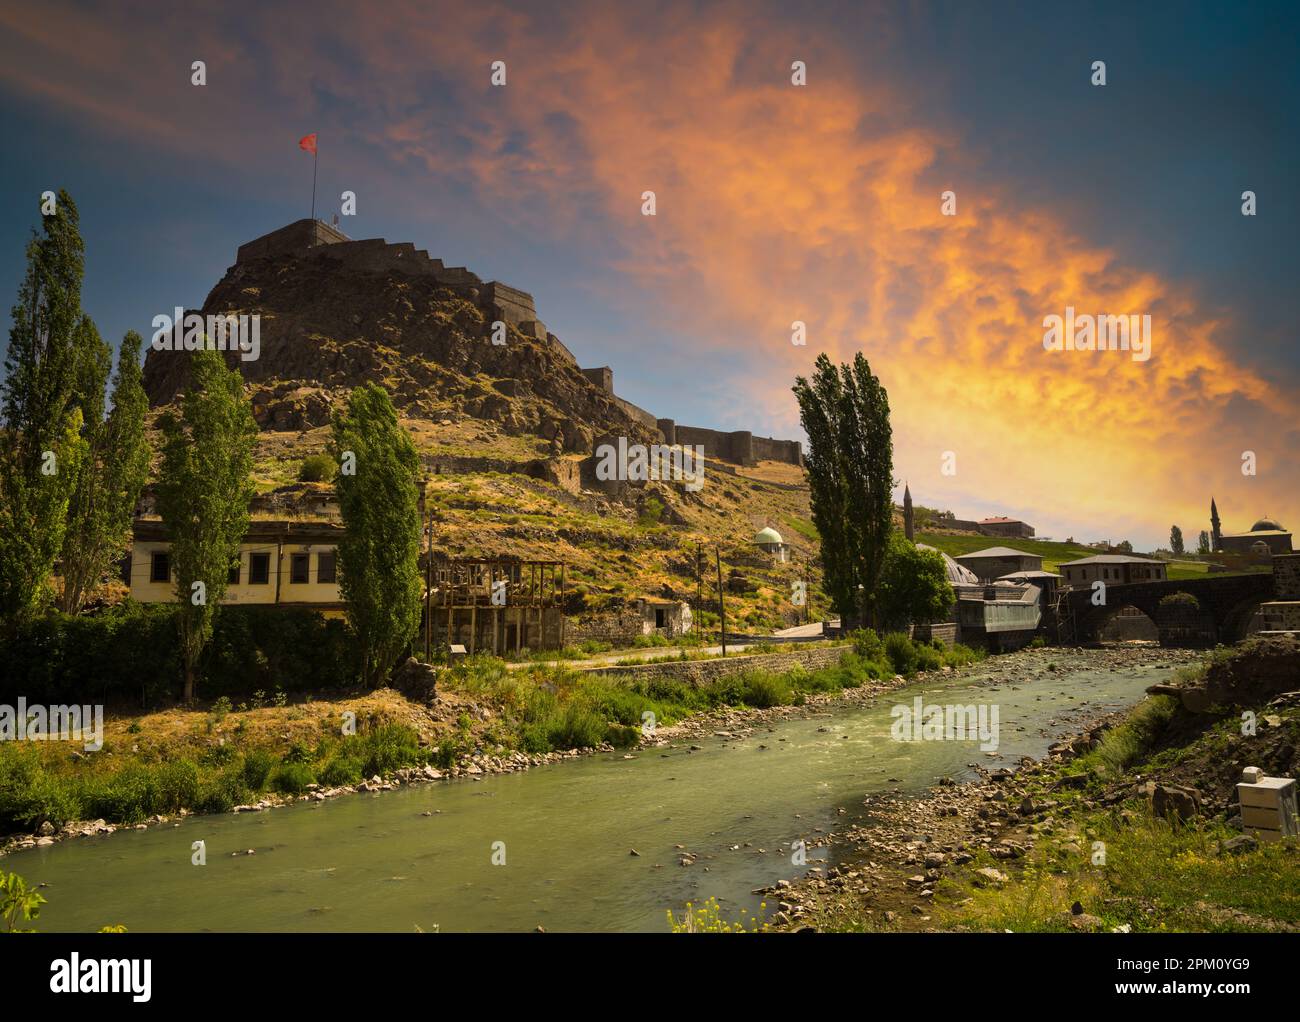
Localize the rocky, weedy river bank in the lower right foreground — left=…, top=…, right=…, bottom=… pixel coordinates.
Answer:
left=763, top=650, right=1300, bottom=932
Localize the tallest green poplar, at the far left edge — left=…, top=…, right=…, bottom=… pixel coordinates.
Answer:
left=0, top=191, right=86, bottom=624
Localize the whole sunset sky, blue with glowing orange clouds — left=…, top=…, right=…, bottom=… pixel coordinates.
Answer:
left=0, top=0, right=1300, bottom=549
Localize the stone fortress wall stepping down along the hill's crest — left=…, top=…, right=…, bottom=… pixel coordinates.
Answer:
left=235, top=220, right=803, bottom=465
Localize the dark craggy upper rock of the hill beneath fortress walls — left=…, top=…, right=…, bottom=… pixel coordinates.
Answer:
left=144, top=246, right=658, bottom=454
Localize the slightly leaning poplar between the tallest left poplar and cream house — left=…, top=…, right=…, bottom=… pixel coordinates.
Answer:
left=59, top=328, right=150, bottom=614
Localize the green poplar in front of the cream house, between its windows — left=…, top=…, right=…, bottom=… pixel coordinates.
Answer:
left=157, top=350, right=256, bottom=702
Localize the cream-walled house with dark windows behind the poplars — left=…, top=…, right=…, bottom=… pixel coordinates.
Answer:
left=126, top=519, right=343, bottom=618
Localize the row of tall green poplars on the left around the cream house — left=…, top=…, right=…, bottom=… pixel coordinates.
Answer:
left=0, top=191, right=421, bottom=702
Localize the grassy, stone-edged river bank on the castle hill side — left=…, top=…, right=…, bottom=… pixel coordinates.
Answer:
left=0, top=629, right=975, bottom=854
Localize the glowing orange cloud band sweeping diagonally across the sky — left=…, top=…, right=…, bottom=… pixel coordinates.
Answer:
left=8, top=4, right=1300, bottom=541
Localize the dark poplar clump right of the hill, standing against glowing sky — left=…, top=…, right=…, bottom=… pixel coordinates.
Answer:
left=793, top=352, right=894, bottom=627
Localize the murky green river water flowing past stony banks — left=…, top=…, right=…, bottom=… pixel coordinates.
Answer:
left=4, top=667, right=1171, bottom=932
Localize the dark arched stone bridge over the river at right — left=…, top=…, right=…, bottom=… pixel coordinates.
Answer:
left=1061, top=572, right=1273, bottom=646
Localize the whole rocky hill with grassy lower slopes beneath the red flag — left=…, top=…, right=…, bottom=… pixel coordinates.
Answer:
left=137, top=221, right=826, bottom=629
